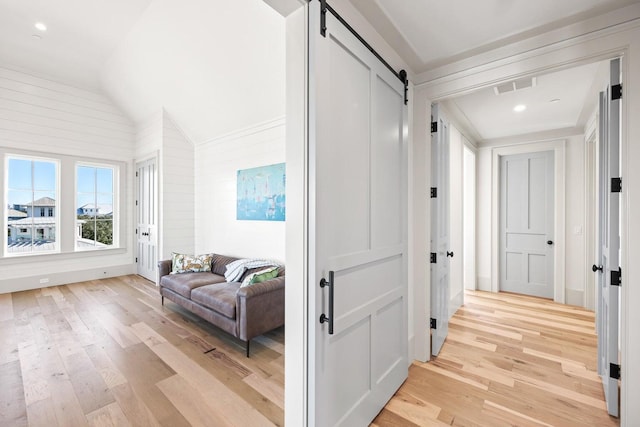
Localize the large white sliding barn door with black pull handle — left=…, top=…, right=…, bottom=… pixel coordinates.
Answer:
left=308, top=2, right=408, bottom=426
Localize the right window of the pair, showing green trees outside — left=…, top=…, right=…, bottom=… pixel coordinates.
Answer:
left=76, top=164, right=117, bottom=250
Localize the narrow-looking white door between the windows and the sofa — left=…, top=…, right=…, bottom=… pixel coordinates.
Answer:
left=136, top=158, right=158, bottom=282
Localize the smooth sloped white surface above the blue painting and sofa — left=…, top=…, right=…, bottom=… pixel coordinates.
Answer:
left=102, top=0, right=285, bottom=144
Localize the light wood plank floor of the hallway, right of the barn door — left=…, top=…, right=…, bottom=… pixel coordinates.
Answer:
left=372, top=292, right=619, bottom=427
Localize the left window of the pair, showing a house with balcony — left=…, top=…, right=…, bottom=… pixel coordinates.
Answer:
left=5, top=156, right=59, bottom=255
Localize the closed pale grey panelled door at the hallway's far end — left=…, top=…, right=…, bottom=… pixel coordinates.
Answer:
left=499, top=151, right=554, bottom=298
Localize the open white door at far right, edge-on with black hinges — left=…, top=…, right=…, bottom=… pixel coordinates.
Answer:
left=593, top=59, right=620, bottom=416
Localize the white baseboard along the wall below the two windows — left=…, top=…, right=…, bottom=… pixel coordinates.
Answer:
left=0, top=264, right=136, bottom=293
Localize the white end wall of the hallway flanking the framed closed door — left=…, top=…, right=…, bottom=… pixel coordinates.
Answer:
left=477, top=135, right=587, bottom=305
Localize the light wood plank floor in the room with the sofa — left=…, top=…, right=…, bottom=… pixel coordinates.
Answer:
left=0, top=276, right=284, bottom=427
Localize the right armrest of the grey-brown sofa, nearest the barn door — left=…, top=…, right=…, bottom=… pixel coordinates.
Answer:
left=236, top=276, right=285, bottom=341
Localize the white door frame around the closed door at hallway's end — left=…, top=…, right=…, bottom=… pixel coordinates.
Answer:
left=491, top=139, right=566, bottom=304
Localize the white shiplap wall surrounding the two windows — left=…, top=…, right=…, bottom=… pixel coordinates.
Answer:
left=0, top=68, right=135, bottom=293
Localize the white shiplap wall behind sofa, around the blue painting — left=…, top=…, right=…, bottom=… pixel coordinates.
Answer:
left=195, top=118, right=286, bottom=262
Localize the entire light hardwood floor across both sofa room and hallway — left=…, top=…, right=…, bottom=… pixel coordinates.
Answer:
left=0, top=276, right=618, bottom=427
